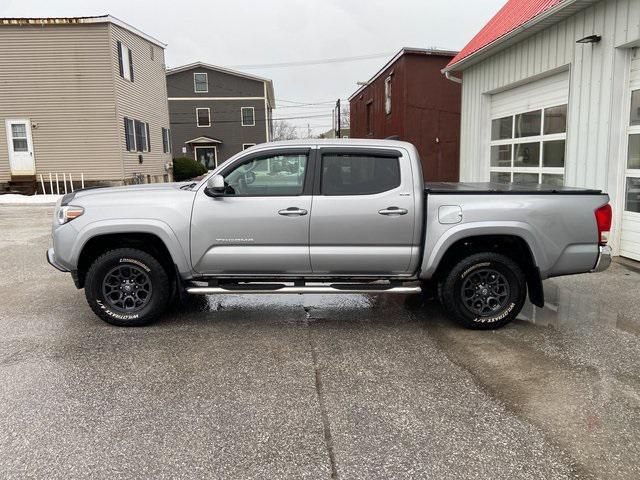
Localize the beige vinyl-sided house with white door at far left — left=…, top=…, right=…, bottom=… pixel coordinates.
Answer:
left=0, top=16, right=171, bottom=192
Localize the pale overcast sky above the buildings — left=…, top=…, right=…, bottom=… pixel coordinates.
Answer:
left=0, top=0, right=506, bottom=134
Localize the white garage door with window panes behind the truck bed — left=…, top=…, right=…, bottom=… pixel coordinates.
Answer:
left=489, top=71, right=569, bottom=185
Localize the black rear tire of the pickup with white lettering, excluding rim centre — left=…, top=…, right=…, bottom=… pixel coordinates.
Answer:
left=438, top=252, right=527, bottom=330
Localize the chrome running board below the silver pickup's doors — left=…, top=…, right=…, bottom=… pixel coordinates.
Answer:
left=187, top=285, right=422, bottom=295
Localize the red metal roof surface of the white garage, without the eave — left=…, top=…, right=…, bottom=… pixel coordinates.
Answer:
left=447, top=0, right=565, bottom=68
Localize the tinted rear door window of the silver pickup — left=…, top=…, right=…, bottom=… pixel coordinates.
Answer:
left=320, top=153, right=400, bottom=195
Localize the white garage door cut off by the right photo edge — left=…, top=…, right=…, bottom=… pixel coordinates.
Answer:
left=620, top=51, right=640, bottom=260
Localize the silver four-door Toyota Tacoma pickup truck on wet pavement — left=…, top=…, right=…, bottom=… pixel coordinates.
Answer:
left=47, top=139, right=611, bottom=329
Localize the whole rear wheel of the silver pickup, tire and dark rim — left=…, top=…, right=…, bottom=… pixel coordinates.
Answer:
left=439, top=252, right=527, bottom=330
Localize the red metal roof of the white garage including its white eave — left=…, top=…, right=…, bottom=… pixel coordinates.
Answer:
left=445, top=0, right=595, bottom=71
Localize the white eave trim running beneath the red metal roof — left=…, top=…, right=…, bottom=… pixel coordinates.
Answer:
left=442, top=0, right=599, bottom=73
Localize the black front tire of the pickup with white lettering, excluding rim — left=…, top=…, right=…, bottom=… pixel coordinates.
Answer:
left=84, top=248, right=171, bottom=327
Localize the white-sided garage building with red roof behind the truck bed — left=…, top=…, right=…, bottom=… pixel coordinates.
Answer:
left=444, top=0, right=640, bottom=260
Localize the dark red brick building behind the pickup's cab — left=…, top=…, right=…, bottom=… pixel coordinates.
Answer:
left=349, top=47, right=462, bottom=182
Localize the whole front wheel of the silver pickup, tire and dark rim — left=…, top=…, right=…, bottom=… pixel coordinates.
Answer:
left=84, top=248, right=171, bottom=327
